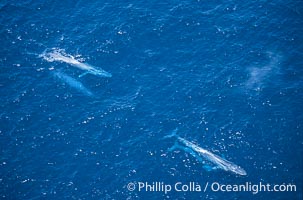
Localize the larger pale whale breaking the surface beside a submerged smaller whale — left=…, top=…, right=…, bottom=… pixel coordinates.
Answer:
left=40, top=49, right=112, bottom=77
